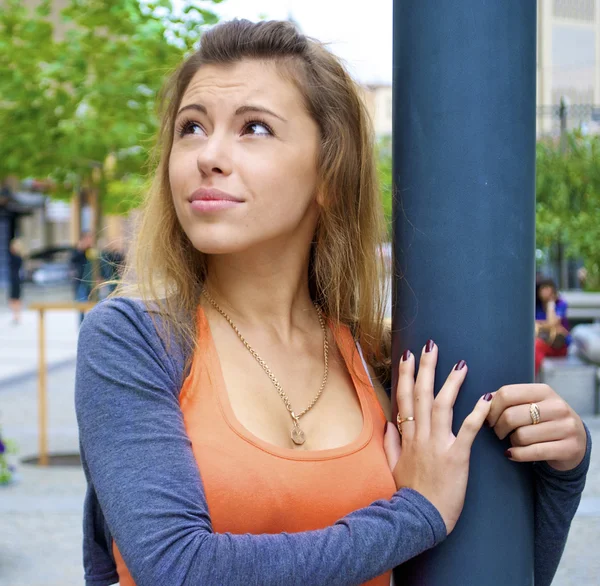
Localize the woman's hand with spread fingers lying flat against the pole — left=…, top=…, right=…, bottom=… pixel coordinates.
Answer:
left=384, top=340, right=492, bottom=534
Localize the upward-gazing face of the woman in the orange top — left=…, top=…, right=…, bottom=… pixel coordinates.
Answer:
left=169, top=60, right=319, bottom=254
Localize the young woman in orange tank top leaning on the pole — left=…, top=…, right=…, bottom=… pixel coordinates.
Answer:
left=76, top=21, right=590, bottom=586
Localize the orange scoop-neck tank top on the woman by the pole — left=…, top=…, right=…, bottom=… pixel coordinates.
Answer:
left=113, top=308, right=396, bottom=586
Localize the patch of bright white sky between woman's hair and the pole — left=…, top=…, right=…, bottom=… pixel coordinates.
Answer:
left=207, top=0, right=392, bottom=84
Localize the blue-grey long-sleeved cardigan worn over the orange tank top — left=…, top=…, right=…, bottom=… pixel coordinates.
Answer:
left=75, top=299, right=591, bottom=586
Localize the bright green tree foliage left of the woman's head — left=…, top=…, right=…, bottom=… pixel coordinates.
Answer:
left=0, top=0, right=221, bottom=213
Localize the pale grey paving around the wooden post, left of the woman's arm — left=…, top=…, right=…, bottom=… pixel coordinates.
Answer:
left=0, top=366, right=85, bottom=586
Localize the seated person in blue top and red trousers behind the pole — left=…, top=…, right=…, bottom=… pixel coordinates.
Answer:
left=535, top=279, right=571, bottom=376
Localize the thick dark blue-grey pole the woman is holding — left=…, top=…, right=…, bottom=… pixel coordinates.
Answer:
left=393, top=0, right=536, bottom=586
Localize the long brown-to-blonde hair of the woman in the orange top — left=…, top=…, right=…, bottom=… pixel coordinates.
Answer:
left=115, top=20, right=389, bottom=370
